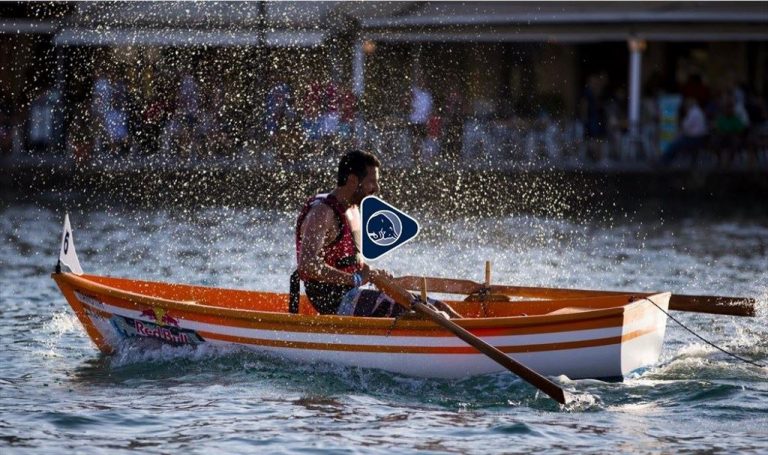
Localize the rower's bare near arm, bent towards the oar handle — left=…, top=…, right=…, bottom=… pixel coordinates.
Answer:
left=299, top=204, right=367, bottom=286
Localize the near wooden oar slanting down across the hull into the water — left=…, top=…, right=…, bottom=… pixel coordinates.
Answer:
left=371, top=275, right=565, bottom=404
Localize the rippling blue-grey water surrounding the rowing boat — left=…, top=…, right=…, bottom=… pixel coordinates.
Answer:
left=0, top=194, right=768, bottom=454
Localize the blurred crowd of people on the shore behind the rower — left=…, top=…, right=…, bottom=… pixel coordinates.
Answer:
left=0, top=72, right=768, bottom=171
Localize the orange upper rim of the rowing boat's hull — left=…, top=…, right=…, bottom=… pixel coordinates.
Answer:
left=51, top=272, right=669, bottom=331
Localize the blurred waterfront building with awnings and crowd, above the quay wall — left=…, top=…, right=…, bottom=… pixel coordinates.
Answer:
left=0, top=2, right=768, bottom=183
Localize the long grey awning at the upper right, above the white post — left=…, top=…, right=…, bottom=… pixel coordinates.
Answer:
left=359, top=2, right=768, bottom=43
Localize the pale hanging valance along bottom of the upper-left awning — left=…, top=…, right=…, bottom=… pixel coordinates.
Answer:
left=53, top=28, right=328, bottom=47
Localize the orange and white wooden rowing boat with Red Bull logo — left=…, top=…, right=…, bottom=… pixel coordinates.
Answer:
left=52, top=219, right=670, bottom=379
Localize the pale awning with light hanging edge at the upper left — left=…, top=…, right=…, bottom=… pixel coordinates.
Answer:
left=54, top=1, right=335, bottom=47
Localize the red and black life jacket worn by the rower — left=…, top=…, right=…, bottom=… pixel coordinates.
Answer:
left=288, top=194, right=362, bottom=314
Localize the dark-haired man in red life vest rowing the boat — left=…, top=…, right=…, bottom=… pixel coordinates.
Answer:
left=290, top=150, right=456, bottom=317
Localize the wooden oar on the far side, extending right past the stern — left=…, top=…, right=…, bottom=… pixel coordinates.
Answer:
left=395, top=276, right=756, bottom=316
